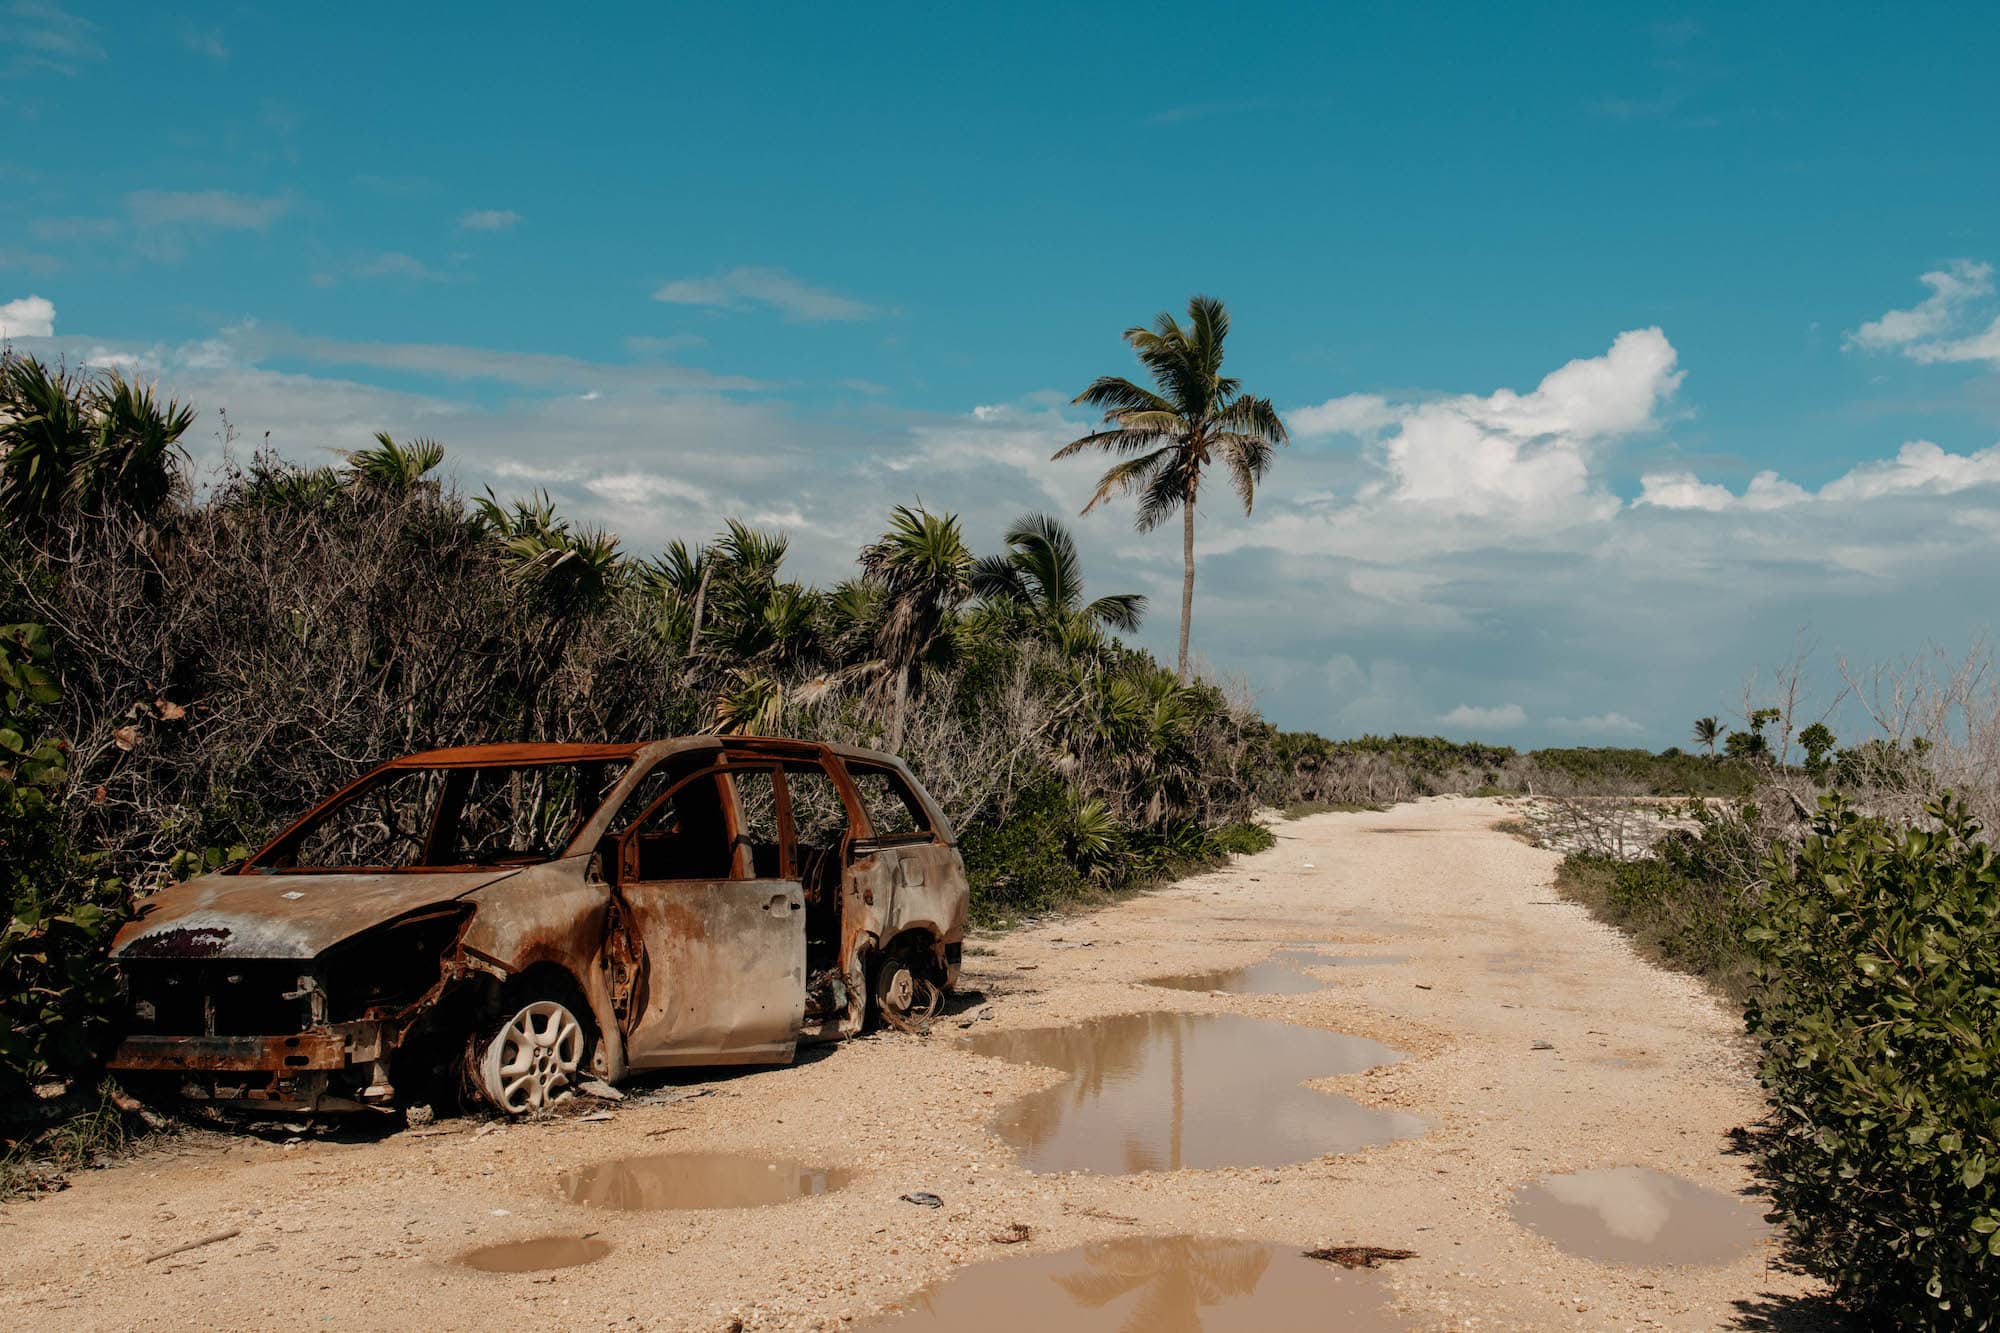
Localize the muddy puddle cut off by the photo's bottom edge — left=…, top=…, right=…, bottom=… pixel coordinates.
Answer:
left=862, top=1237, right=1408, bottom=1333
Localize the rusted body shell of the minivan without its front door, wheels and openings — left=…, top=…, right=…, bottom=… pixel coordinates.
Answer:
left=112, top=737, right=966, bottom=1111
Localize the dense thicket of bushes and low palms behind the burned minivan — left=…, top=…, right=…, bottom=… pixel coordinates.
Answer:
left=0, top=352, right=1270, bottom=1112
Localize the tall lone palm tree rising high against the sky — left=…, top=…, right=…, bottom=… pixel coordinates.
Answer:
left=1056, top=296, right=1290, bottom=681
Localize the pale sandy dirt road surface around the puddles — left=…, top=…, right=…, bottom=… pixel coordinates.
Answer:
left=0, top=799, right=1814, bottom=1329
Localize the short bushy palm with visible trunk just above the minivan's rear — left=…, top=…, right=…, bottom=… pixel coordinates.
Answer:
left=862, top=504, right=974, bottom=751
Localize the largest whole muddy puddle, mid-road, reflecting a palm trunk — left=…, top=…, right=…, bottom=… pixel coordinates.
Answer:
left=962, top=1013, right=1424, bottom=1175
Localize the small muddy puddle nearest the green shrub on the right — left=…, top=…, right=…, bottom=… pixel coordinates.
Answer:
left=1514, top=1167, right=1770, bottom=1265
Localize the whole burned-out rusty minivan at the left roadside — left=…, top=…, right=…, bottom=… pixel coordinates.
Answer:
left=112, top=737, right=968, bottom=1113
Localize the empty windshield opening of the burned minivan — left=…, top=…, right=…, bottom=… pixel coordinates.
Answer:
left=244, top=761, right=628, bottom=873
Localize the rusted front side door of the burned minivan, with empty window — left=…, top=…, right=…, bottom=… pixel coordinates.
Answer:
left=616, top=765, right=806, bottom=1069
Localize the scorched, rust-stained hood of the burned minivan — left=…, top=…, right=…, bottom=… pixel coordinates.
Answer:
left=112, top=867, right=520, bottom=959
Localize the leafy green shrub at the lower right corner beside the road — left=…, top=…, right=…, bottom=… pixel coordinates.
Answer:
left=1748, top=799, right=2000, bottom=1329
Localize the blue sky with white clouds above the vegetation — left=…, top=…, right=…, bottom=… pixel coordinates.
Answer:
left=0, top=0, right=2000, bottom=747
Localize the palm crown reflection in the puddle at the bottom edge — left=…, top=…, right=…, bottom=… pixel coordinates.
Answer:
left=1054, top=1235, right=1272, bottom=1333
